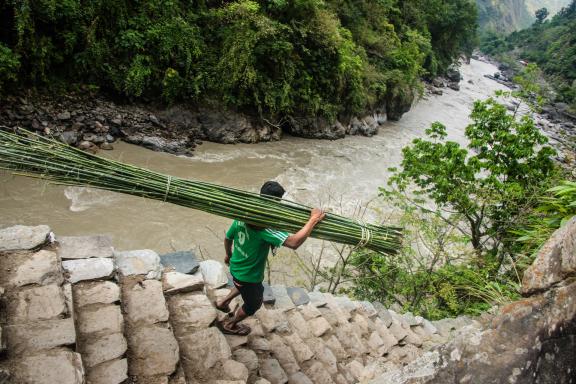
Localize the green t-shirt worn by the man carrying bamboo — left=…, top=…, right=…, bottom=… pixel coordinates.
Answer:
left=226, top=220, right=288, bottom=283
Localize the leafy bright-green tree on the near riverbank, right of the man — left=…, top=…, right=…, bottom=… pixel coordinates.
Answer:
left=385, top=99, right=555, bottom=264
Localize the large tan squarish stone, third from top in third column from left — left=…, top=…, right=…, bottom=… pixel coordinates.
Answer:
left=128, top=326, right=179, bottom=376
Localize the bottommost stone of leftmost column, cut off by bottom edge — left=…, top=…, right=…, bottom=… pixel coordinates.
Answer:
left=9, top=349, right=84, bottom=384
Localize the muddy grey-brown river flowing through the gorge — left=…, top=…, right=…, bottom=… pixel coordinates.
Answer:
left=0, top=60, right=504, bottom=282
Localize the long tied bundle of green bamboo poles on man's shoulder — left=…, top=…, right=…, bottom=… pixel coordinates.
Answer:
left=0, top=127, right=401, bottom=254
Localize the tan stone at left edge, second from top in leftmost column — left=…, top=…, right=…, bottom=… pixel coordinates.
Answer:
left=0, top=250, right=62, bottom=288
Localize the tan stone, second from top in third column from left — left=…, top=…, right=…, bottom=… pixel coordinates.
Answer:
left=122, top=280, right=169, bottom=324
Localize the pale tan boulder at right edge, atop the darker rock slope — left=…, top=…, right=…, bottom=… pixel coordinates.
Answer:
left=522, top=217, right=576, bottom=294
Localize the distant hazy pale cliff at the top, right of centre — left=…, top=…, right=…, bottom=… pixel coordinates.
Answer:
left=476, top=0, right=542, bottom=33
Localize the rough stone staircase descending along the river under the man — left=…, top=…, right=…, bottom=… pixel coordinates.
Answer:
left=0, top=226, right=475, bottom=384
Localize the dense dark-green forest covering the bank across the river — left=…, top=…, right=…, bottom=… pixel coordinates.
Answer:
left=0, top=0, right=476, bottom=119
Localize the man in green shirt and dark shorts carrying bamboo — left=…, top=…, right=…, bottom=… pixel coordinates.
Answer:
left=216, top=181, right=326, bottom=335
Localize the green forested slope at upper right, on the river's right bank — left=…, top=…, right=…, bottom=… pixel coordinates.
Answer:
left=482, top=0, right=576, bottom=108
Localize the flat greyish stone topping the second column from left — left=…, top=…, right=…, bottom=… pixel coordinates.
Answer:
left=58, top=235, right=114, bottom=259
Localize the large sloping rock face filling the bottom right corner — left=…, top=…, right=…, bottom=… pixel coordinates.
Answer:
left=373, top=218, right=576, bottom=384
